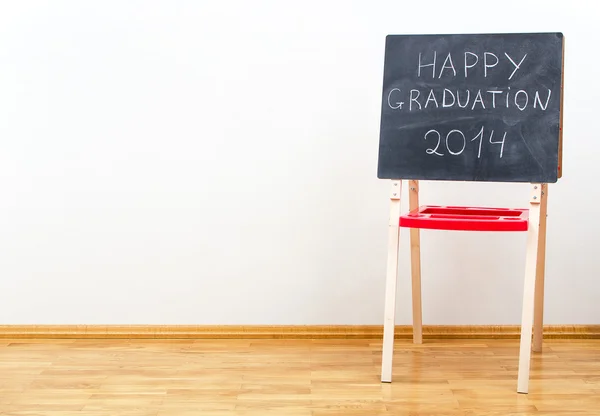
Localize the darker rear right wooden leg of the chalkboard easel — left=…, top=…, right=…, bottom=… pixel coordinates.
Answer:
left=533, top=184, right=548, bottom=352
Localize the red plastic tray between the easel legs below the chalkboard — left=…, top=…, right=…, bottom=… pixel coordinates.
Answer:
left=400, top=205, right=529, bottom=231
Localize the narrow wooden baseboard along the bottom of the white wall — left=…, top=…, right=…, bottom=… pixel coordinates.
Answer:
left=0, top=325, right=600, bottom=339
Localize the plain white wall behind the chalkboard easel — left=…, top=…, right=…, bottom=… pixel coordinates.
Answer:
left=0, top=0, right=600, bottom=324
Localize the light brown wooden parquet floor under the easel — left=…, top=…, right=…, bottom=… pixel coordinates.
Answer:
left=0, top=340, right=600, bottom=416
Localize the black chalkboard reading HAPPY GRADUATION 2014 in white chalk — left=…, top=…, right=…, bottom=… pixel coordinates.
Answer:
left=377, top=33, right=564, bottom=183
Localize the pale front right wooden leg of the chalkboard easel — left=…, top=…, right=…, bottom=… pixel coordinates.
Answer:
left=517, top=184, right=542, bottom=393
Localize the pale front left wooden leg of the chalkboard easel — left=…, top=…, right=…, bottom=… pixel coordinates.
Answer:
left=381, top=180, right=402, bottom=383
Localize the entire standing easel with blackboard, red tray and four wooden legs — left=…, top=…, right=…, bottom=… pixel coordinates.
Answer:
left=378, top=33, right=564, bottom=393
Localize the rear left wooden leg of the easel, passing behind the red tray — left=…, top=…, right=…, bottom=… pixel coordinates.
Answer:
left=408, top=180, right=423, bottom=344
